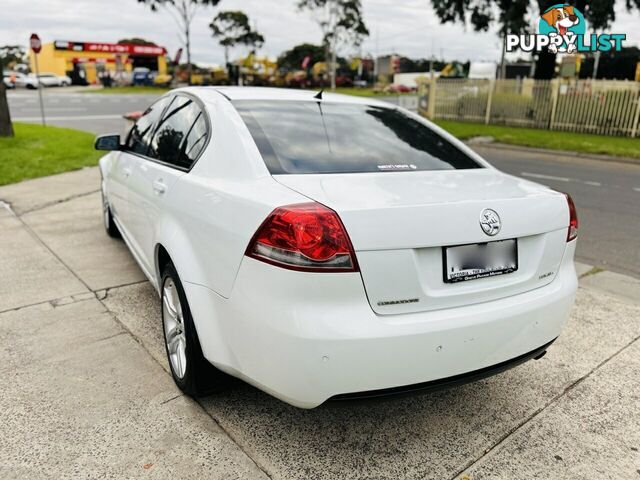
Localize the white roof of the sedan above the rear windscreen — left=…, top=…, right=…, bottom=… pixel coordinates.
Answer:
left=179, top=87, right=393, bottom=107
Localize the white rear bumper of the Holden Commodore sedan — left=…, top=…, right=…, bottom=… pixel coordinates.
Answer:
left=185, top=242, right=577, bottom=408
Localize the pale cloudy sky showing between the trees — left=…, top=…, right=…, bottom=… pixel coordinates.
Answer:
left=0, top=0, right=640, bottom=64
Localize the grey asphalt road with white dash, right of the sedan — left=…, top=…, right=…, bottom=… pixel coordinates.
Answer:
left=474, top=148, right=640, bottom=278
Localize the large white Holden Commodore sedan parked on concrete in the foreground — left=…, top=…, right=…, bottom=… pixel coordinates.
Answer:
left=96, top=87, right=578, bottom=408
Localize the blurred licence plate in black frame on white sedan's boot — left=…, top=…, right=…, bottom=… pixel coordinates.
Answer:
left=442, top=238, right=518, bottom=283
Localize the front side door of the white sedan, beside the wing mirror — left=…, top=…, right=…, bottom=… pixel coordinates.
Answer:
left=107, top=93, right=172, bottom=251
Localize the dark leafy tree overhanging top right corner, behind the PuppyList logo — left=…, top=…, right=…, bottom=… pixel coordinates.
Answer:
left=431, top=0, right=640, bottom=78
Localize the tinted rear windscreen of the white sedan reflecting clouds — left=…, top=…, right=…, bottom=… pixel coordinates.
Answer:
left=233, top=100, right=482, bottom=175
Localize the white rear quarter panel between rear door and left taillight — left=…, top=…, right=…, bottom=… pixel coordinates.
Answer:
left=156, top=94, right=308, bottom=298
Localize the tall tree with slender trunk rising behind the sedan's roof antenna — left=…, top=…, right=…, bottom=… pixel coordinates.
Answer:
left=298, top=0, right=369, bottom=89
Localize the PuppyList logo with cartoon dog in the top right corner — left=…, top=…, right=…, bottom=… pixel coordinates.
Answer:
left=506, top=3, right=627, bottom=53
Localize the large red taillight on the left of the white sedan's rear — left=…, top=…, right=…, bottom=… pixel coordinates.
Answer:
left=246, top=203, right=358, bottom=272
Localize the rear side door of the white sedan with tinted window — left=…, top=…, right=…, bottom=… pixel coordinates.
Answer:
left=129, top=94, right=208, bottom=272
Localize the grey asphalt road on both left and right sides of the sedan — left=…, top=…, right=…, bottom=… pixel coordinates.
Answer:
left=9, top=89, right=640, bottom=278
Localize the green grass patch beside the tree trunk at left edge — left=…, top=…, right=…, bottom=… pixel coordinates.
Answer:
left=0, top=123, right=102, bottom=185
